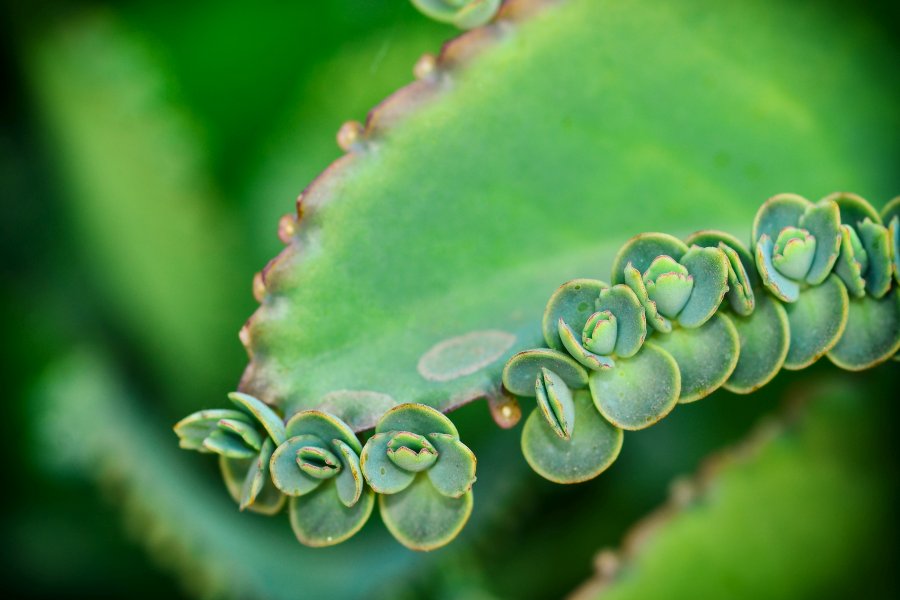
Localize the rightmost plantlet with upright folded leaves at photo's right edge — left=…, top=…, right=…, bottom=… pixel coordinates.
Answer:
left=826, top=193, right=900, bottom=371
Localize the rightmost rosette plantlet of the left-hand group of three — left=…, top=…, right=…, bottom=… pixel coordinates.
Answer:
left=360, top=404, right=475, bottom=550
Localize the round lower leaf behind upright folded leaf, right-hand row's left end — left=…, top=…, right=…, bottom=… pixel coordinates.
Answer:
left=522, top=390, right=625, bottom=483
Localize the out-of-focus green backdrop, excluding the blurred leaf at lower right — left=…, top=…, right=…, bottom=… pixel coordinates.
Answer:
left=0, top=0, right=897, bottom=598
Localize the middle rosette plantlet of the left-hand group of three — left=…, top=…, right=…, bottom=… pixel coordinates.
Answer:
left=270, top=410, right=375, bottom=546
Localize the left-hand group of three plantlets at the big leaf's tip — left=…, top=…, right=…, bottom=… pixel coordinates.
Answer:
left=175, top=392, right=475, bottom=550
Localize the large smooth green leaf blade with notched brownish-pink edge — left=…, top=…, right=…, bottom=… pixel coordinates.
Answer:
left=242, top=0, right=898, bottom=428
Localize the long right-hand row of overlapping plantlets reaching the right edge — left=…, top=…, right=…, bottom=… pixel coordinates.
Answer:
left=503, top=193, right=900, bottom=483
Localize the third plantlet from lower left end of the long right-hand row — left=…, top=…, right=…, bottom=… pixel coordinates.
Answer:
left=612, top=233, right=740, bottom=402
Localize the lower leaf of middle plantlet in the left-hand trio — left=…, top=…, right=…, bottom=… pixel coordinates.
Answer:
left=288, top=479, right=375, bottom=547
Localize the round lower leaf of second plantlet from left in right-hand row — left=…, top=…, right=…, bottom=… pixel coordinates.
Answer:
left=590, top=342, right=681, bottom=430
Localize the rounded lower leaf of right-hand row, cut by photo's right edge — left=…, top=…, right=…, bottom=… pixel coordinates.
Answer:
left=828, top=287, right=900, bottom=371
